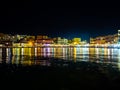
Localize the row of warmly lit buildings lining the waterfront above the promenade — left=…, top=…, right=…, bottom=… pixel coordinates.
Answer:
left=0, top=30, right=120, bottom=46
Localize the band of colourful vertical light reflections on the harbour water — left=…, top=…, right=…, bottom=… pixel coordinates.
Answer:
left=0, top=46, right=120, bottom=68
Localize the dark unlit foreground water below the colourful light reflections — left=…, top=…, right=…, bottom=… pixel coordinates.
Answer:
left=0, top=59, right=120, bottom=90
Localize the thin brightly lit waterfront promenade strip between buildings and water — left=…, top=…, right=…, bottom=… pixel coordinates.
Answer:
left=0, top=44, right=120, bottom=49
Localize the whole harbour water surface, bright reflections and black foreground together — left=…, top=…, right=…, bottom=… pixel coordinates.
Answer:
left=0, top=48, right=120, bottom=90
